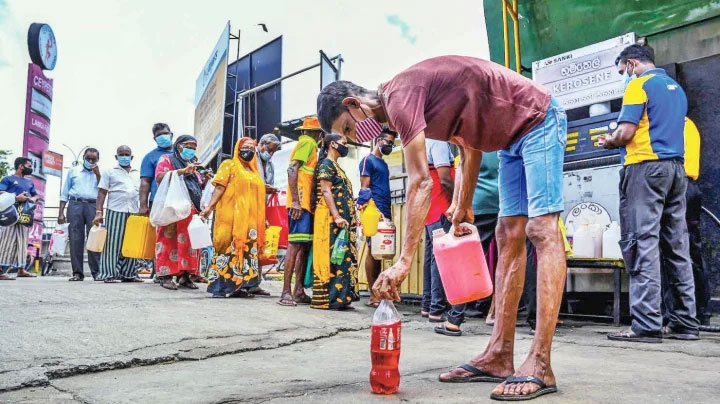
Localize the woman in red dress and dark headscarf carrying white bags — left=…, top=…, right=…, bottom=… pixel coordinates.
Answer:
left=151, top=135, right=204, bottom=290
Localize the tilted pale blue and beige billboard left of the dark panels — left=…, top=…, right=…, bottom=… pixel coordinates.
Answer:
left=194, top=21, right=230, bottom=165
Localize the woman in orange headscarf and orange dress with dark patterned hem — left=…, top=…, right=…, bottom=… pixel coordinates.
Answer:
left=201, top=137, right=265, bottom=297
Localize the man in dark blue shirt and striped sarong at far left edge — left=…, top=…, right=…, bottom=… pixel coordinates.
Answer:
left=0, top=157, right=38, bottom=281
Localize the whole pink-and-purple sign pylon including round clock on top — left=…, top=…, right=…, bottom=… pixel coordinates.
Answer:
left=23, top=23, right=57, bottom=251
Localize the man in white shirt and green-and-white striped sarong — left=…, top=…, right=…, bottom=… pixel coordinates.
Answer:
left=93, top=146, right=143, bottom=283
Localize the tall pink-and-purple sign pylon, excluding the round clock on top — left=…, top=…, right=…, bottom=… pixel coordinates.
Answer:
left=23, top=63, right=53, bottom=248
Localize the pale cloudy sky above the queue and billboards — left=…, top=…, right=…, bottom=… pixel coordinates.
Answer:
left=0, top=0, right=489, bottom=206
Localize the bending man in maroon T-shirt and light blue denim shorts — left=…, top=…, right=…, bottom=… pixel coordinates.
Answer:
left=317, top=56, right=567, bottom=400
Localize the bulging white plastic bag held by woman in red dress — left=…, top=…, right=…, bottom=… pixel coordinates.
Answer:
left=150, top=171, right=192, bottom=227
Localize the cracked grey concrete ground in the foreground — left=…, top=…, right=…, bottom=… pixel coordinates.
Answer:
left=0, top=277, right=720, bottom=403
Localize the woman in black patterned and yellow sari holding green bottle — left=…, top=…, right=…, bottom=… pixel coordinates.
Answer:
left=310, top=134, right=357, bottom=310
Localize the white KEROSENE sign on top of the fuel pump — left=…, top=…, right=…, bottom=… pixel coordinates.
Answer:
left=532, top=32, right=635, bottom=109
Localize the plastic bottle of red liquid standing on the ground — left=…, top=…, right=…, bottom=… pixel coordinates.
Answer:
left=370, top=300, right=402, bottom=394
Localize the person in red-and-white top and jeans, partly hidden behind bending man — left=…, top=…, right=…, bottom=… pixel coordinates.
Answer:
left=422, top=139, right=455, bottom=323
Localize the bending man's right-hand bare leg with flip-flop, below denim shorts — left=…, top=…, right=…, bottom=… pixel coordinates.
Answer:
left=493, top=213, right=567, bottom=395
